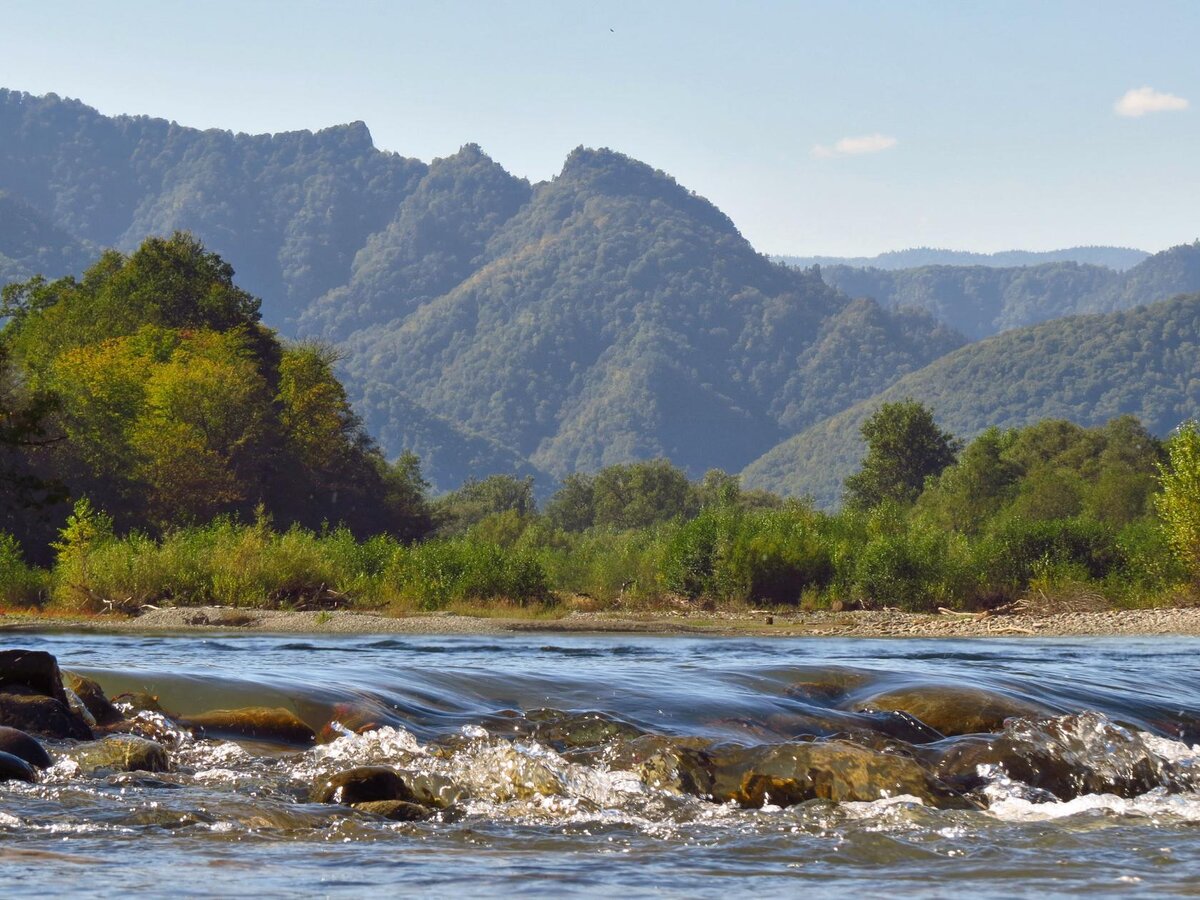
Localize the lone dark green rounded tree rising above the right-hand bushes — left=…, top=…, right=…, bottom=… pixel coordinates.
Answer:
left=846, top=400, right=961, bottom=509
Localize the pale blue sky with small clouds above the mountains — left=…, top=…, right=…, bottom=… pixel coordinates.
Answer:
left=0, top=0, right=1200, bottom=254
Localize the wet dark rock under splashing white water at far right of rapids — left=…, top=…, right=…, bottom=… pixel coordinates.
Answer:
left=931, top=713, right=1176, bottom=800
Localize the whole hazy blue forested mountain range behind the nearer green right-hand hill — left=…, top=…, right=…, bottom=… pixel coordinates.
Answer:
left=0, top=90, right=1200, bottom=496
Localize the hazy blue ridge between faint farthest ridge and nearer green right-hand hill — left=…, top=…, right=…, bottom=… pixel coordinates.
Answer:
left=820, top=242, right=1200, bottom=340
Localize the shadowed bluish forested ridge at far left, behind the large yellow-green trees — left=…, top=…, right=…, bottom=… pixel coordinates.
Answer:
left=0, top=90, right=428, bottom=331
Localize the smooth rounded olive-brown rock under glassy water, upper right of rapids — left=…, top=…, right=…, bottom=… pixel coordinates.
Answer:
left=854, top=685, right=1054, bottom=737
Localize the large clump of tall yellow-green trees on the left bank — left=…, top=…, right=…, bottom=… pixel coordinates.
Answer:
left=0, top=234, right=431, bottom=553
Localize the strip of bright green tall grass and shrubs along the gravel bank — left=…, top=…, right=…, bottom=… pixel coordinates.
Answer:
left=16, top=489, right=1187, bottom=612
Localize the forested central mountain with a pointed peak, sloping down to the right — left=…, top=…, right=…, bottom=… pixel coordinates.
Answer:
left=346, top=148, right=962, bottom=475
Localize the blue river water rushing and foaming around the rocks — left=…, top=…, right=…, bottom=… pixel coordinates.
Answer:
left=0, top=634, right=1200, bottom=898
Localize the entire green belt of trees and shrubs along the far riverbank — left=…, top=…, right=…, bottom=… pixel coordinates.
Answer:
left=0, top=235, right=1200, bottom=612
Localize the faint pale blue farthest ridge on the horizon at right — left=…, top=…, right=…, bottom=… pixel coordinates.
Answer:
left=775, top=247, right=1150, bottom=271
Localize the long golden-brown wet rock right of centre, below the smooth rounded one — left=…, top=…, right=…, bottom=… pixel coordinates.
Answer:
left=713, top=740, right=968, bottom=808
